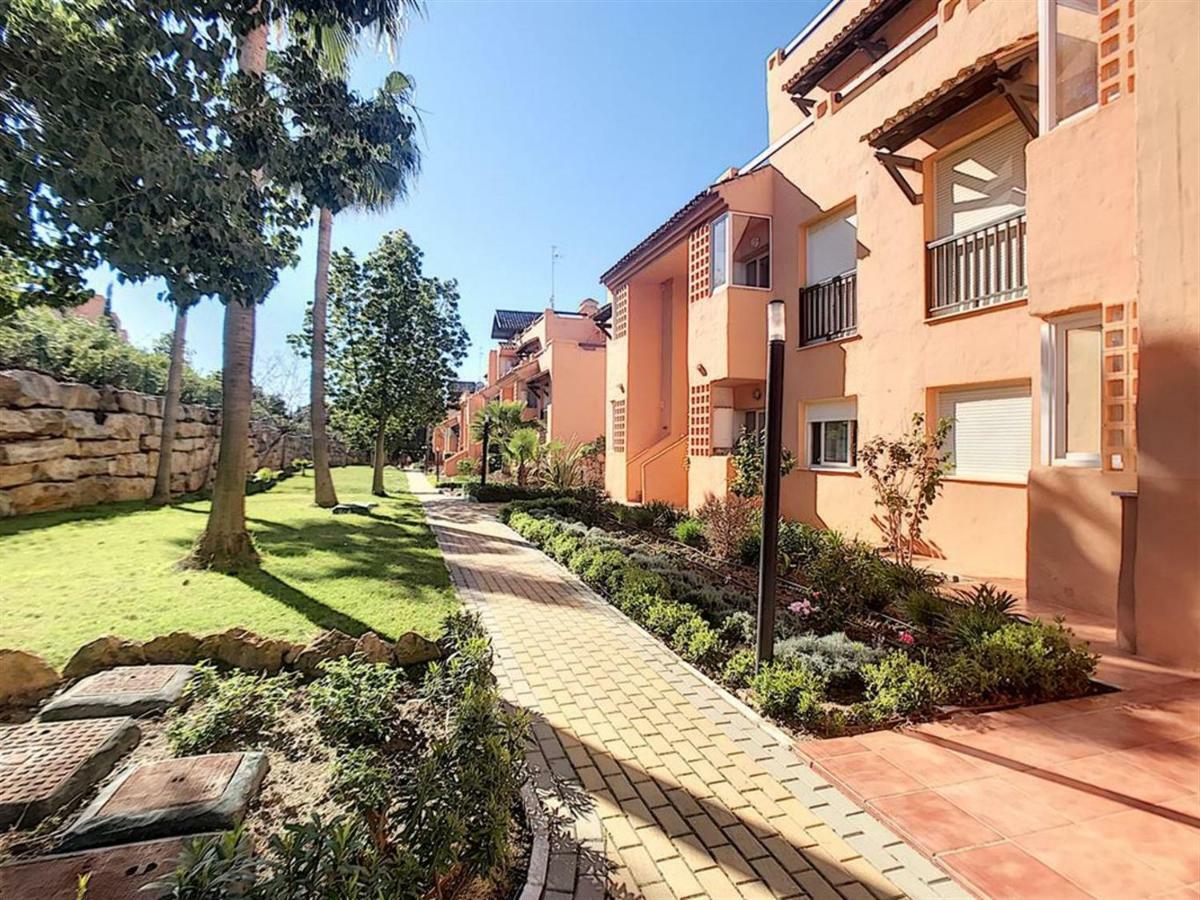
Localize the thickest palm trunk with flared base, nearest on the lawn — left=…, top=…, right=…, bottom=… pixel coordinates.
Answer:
left=184, top=24, right=266, bottom=571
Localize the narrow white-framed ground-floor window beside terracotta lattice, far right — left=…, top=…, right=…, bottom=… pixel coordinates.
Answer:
left=1042, top=310, right=1103, bottom=467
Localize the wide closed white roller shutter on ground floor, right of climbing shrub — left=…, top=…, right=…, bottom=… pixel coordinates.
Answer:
left=937, top=386, right=1033, bottom=481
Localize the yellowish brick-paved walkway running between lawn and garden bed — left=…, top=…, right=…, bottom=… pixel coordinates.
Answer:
left=409, top=474, right=966, bottom=900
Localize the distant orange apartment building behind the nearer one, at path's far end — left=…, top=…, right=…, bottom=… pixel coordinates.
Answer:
left=433, top=298, right=607, bottom=475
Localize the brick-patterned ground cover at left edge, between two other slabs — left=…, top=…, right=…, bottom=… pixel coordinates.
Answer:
left=0, top=716, right=142, bottom=828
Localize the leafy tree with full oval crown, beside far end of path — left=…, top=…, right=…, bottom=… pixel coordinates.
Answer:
left=329, top=236, right=468, bottom=496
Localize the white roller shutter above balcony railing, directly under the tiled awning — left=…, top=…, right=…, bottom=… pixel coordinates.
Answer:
left=934, top=122, right=1030, bottom=238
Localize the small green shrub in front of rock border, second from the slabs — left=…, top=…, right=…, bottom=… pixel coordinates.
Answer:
left=308, top=657, right=412, bottom=746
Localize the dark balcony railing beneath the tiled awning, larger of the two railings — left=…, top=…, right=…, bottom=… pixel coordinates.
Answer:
left=929, top=210, right=1027, bottom=317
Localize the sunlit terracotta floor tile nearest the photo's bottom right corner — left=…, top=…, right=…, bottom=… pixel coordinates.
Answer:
left=1015, top=826, right=1181, bottom=900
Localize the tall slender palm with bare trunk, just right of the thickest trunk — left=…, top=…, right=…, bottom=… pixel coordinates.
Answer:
left=278, top=46, right=420, bottom=508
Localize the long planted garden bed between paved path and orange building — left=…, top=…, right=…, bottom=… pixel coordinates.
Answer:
left=502, top=496, right=1100, bottom=737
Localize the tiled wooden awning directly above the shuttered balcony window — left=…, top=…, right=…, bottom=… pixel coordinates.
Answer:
left=863, top=35, right=1038, bottom=154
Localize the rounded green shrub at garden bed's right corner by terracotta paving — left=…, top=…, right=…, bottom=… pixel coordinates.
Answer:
left=946, top=620, right=1099, bottom=703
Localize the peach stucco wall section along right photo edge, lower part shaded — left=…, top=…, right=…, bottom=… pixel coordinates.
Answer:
left=1135, top=2, right=1200, bottom=668
